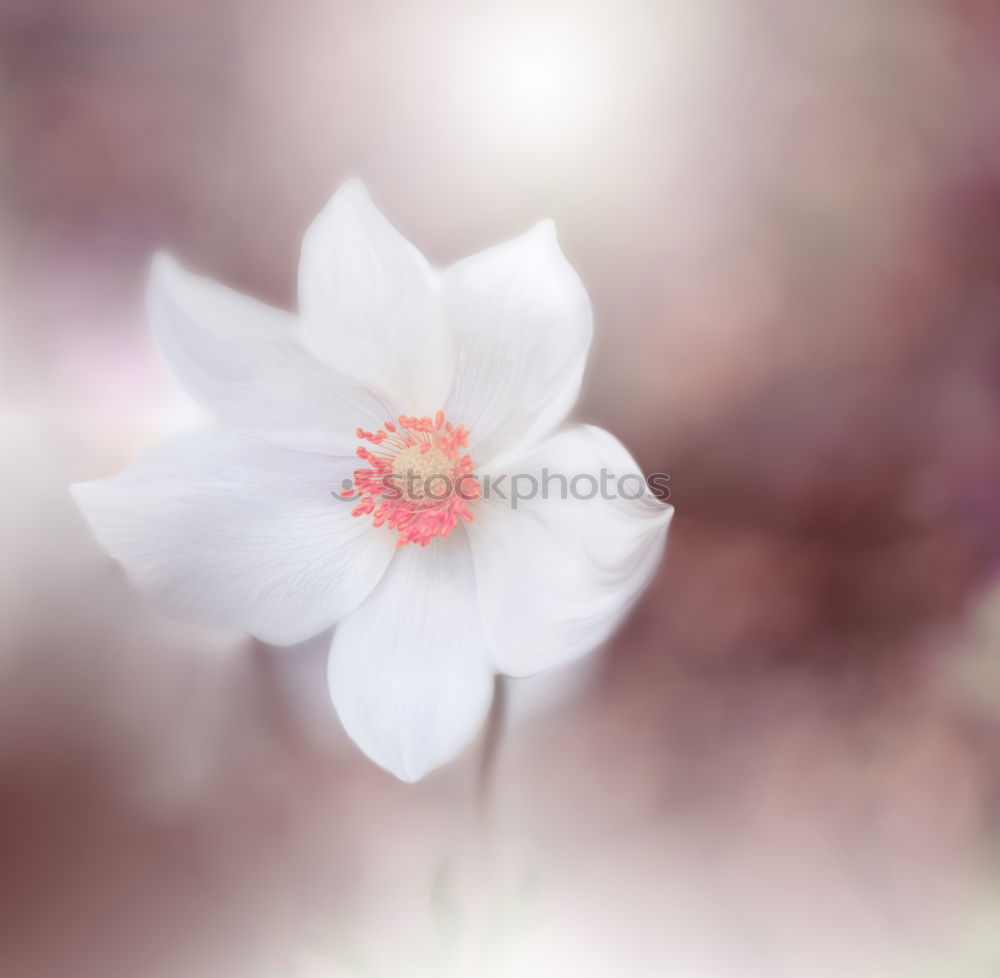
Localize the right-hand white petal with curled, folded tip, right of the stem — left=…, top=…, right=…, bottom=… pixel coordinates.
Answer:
left=466, top=426, right=673, bottom=676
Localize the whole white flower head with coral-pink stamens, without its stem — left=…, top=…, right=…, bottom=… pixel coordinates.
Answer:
left=73, top=182, right=672, bottom=781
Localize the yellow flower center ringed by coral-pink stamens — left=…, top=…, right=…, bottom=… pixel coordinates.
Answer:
left=341, top=411, right=479, bottom=547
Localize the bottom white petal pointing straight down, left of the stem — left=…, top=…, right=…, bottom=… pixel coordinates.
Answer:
left=328, top=532, right=493, bottom=781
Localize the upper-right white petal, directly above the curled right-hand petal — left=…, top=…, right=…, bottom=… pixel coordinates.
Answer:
left=443, top=221, right=592, bottom=466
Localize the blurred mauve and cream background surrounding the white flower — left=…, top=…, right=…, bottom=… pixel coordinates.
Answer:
left=0, top=0, right=1000, bottom=978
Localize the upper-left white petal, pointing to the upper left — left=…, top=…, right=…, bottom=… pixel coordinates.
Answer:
left=149, top=255, right=391, bottom=455
